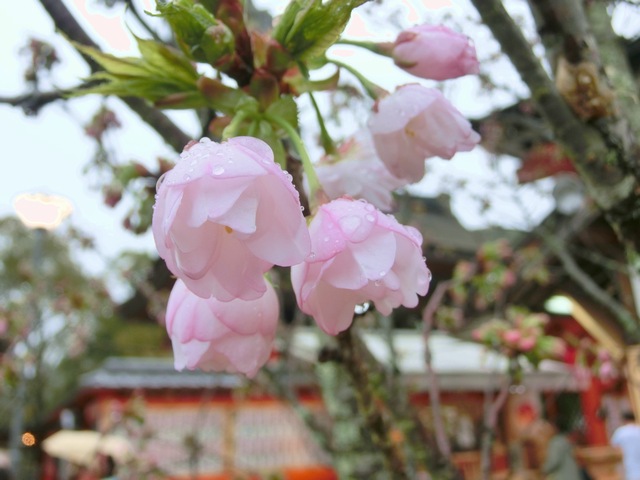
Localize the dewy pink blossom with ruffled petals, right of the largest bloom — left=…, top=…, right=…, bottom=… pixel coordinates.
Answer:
left=291, top=198, right=431, bottom=335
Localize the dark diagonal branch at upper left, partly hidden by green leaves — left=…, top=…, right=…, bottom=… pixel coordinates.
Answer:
left=40, top=0, right=191, bottom=152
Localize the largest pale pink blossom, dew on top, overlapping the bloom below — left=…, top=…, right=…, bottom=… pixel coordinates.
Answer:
left=152, top=137, right=310, bottom=301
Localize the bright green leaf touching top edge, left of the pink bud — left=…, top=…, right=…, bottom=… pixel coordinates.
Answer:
left=273, top=0, right=367, bottom=62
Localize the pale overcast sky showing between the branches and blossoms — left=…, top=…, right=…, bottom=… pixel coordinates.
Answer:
left=0, top=0, right=640, bottom=292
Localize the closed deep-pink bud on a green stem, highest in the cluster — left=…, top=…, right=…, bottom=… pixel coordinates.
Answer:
left=393, top=24, right=480, bottom=80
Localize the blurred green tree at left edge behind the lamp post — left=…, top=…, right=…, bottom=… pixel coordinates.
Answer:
left=0, top=217, right=113, bottom=427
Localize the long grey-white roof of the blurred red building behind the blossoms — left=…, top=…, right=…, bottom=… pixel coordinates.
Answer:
left=81, top=327, right=578, bottom=391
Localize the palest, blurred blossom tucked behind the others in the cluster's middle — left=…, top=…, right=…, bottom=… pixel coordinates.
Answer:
left=315, top=129, right=407, bottom=211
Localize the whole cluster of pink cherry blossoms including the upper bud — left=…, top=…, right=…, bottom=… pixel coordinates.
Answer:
left=152, top=13, right=479, bottom=377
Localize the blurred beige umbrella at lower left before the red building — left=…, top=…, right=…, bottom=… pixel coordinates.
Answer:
left=42, top=430, right=133, bottom=466
